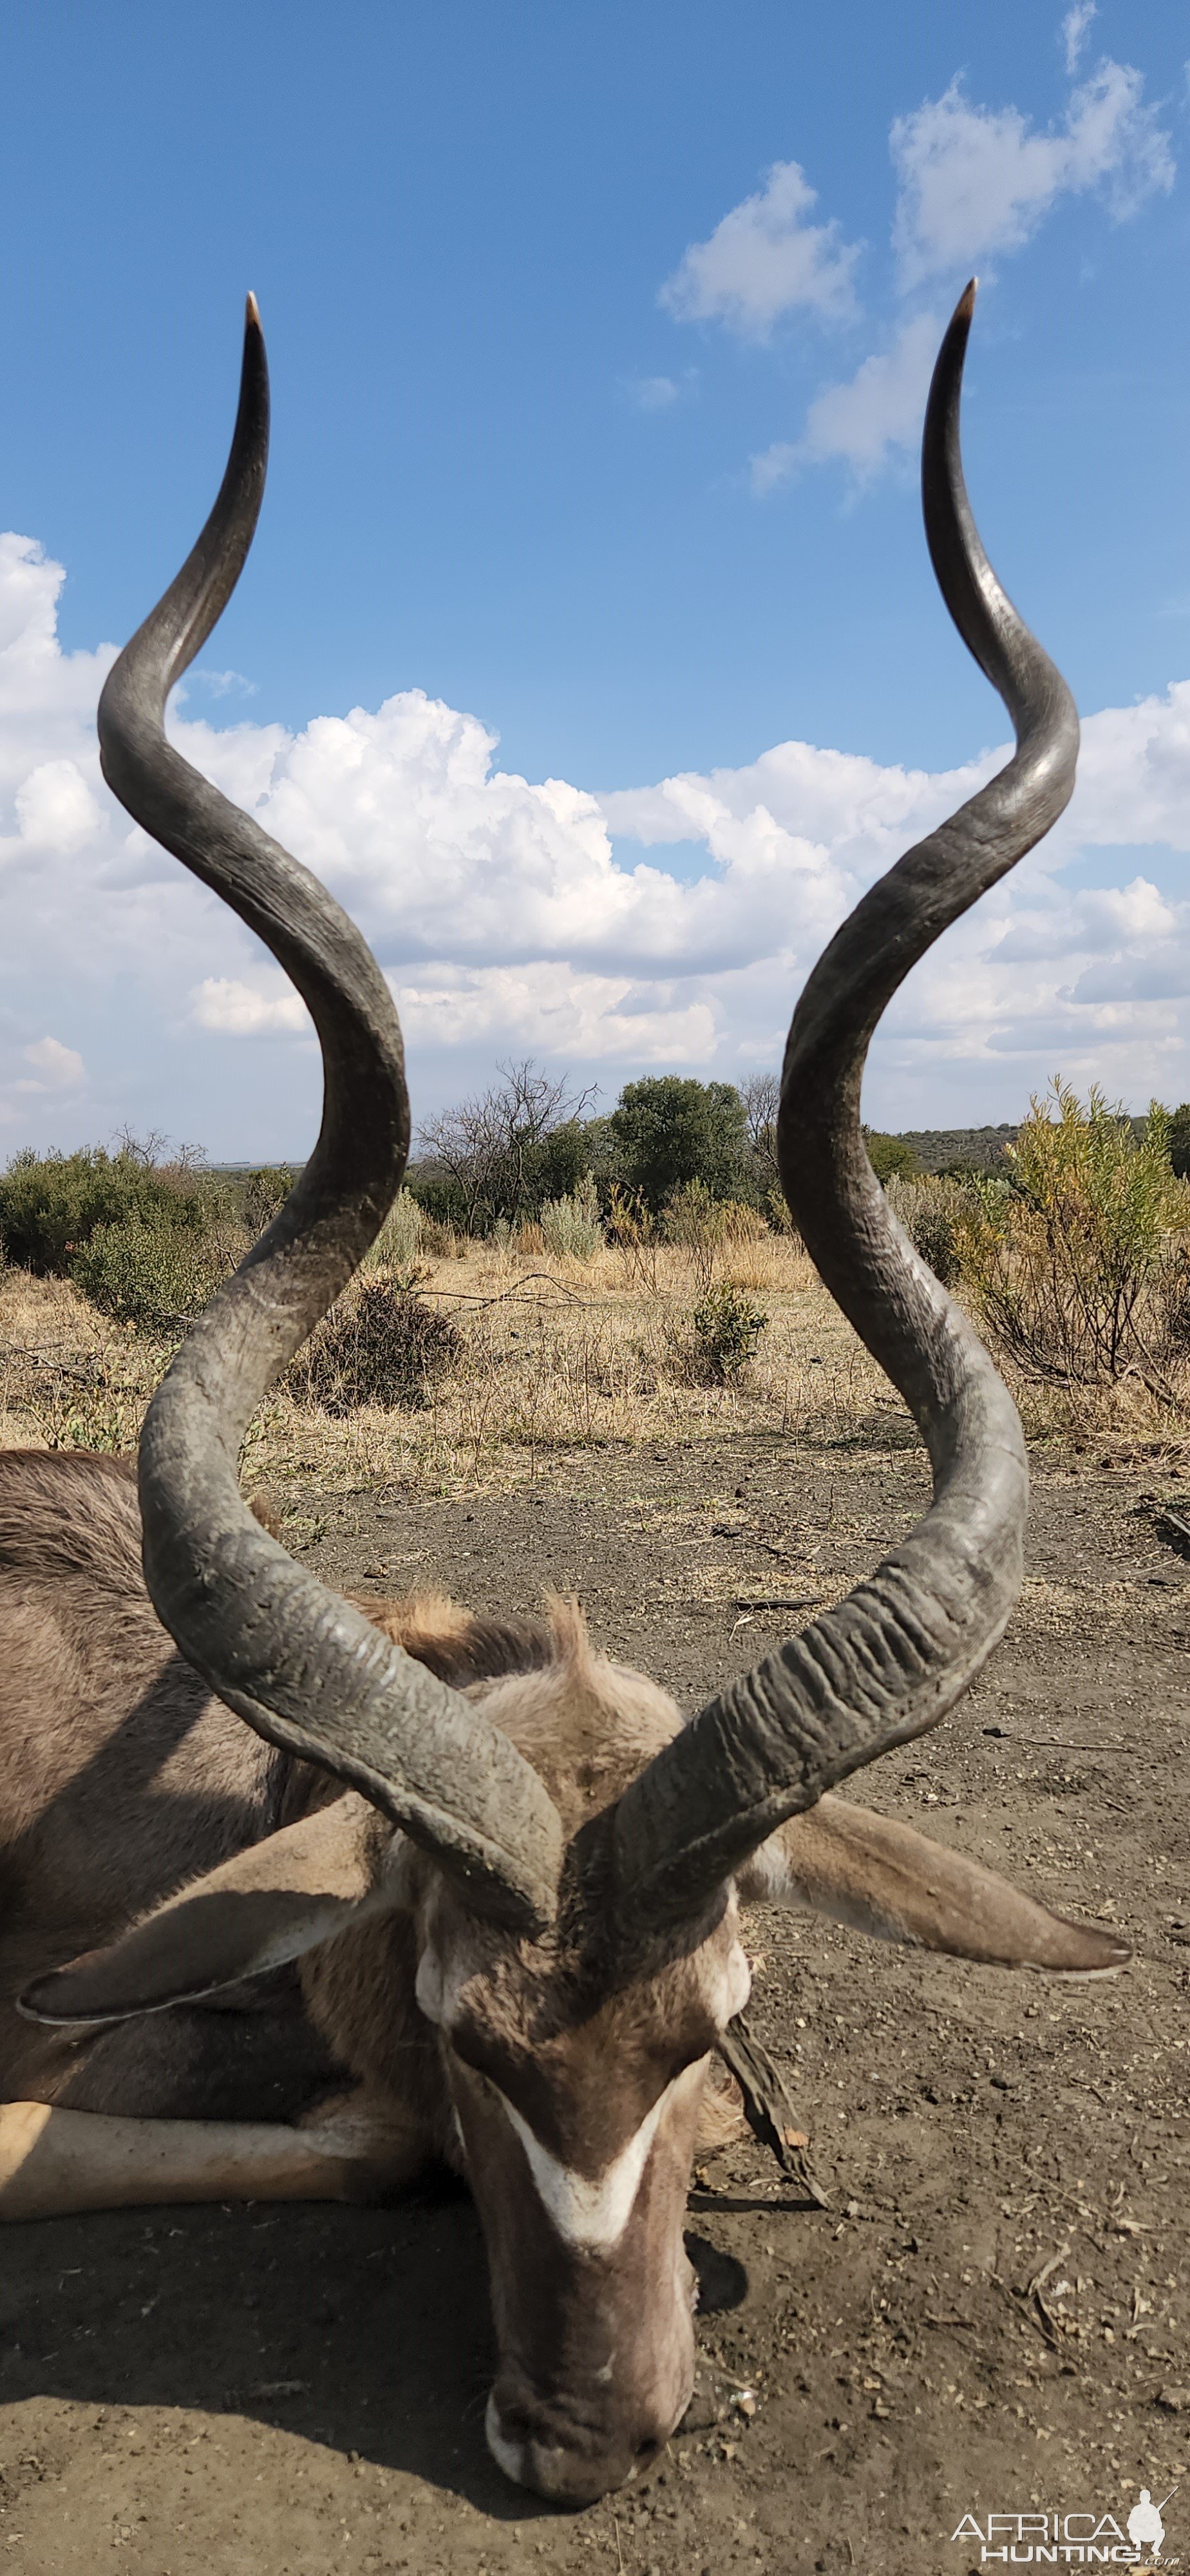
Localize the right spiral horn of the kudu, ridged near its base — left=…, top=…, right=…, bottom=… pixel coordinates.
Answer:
left=610, top=286, right=1079, bottom=1932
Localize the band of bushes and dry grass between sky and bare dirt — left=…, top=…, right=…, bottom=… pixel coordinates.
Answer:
left=0, top=1064, right=1190, bottom=1492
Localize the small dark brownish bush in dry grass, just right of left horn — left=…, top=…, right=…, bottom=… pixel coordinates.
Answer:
left=286, top=1270, right=461, bottom=1419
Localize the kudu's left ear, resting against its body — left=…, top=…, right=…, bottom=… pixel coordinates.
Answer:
left=18, top=1793, right=402, bottom=2025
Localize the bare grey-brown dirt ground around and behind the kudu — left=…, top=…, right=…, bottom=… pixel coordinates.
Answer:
left=0, top=1435, right=1190, bottom=2576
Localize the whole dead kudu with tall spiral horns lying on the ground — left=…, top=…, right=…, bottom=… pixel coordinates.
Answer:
left=0, top=291, right=1126, bottom=2501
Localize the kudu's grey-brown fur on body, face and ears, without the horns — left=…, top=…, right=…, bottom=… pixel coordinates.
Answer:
left=0, top=1450, right=1120, bottom=2501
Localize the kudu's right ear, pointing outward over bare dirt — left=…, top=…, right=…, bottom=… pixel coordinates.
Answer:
left=737, top=1798, right=1131, bottom=1976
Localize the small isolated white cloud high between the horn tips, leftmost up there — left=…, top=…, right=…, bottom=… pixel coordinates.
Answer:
left=659, top=162, right=860, bottom=340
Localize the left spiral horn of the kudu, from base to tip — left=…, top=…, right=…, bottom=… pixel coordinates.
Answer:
left=98, top=299, right=562, bottom=1932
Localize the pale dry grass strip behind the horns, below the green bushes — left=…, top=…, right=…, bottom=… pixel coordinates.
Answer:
left=0, top=1236, right=1187, bottom=1497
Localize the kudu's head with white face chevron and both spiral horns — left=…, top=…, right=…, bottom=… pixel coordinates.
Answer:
left=25, top=289, right=1120, bottom=2501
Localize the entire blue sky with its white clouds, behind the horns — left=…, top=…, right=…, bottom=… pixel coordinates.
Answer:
left=0, top=0, right=1190, bottom=1154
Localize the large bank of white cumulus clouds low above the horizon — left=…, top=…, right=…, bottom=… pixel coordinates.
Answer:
left=0, top=538, right=1190, bottom=1157
